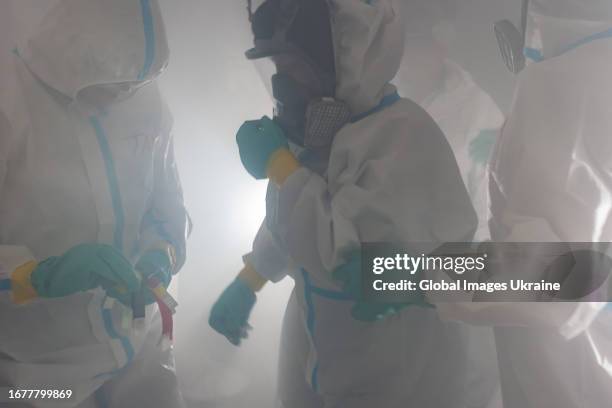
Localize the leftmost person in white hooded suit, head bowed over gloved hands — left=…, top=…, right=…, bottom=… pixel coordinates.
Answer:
left=0, top=0, right=188, bottom=408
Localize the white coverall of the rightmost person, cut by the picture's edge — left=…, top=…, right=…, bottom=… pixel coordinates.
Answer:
left=438, top=0, right=612, bottom=408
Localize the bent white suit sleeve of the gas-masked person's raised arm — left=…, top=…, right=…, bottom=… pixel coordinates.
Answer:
left=273, top=100, right=477, bottom=285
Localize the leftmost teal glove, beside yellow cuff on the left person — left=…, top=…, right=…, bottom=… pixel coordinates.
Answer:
left=31, top=244, right=140, bottom=298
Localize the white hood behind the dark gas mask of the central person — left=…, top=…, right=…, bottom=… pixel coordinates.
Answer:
left=328, top=0, right=404, bottom=115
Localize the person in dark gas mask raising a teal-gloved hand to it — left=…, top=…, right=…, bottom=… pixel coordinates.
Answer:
left=209, top=0, right=477, bottom=408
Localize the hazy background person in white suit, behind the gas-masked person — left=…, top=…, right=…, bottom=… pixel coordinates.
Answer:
left=395, top=0, right=504, bottom=407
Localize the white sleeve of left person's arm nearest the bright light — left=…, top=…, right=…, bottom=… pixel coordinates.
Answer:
left=139, top=108, right=190, bottom=273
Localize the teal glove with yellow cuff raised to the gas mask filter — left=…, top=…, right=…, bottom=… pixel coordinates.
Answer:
left=236, top=116, right=289, bottom=180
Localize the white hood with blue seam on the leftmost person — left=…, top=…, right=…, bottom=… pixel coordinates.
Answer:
left=18, top=0, right=169, bottom=98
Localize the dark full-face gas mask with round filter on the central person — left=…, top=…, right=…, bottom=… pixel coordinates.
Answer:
left=245, top=0, right=352, bottom=149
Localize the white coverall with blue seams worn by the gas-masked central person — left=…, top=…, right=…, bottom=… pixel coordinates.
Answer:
left=246, top=0, right=477, bottom=408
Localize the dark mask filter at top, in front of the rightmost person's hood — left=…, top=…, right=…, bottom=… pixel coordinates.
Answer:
left=494, top=0, right=529, bottom=74
